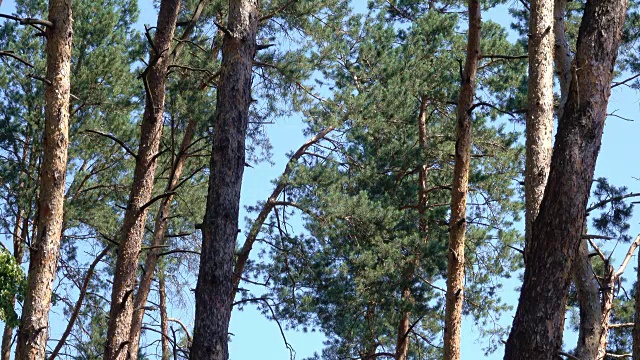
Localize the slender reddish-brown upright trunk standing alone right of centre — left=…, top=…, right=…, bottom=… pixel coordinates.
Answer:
left=444, top=0, right=482, bottom=360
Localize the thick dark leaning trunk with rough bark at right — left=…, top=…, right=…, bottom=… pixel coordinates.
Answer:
left=505, top=0, right=627, bottom=360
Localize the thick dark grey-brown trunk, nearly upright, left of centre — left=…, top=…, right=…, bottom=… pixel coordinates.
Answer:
left=190, top=0, right=258, bottom=360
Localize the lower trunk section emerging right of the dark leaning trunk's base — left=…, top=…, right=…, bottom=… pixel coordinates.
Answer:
left=573, top=240, right=602, bottom=359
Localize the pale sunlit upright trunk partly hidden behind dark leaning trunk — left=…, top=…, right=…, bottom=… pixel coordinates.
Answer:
left=524, top=0, right=554, bottom=250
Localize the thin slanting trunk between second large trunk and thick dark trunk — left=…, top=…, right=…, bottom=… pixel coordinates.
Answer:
left=129, top=119, right=196, bottom=354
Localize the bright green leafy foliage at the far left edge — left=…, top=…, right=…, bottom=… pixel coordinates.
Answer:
left=0, top=248, right=27, bottom=327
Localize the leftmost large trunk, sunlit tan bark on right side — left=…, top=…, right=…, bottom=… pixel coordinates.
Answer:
left=15, top=0, right=73, bottom=360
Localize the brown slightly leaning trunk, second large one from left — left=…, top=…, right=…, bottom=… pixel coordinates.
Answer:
left=104, top=0, right=180, bottom=360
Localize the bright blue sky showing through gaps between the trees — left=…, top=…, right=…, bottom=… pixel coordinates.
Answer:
left=0, top=0, right=640, bottom=360
